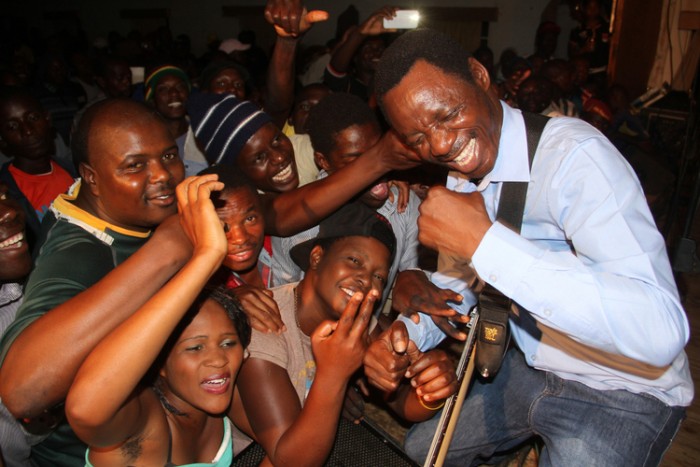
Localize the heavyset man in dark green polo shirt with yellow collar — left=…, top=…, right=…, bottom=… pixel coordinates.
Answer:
left=0, top=99, right=190, bottom=466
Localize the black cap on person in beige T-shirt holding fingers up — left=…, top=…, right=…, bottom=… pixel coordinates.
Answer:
left=289, top=201, right=396, bottom=271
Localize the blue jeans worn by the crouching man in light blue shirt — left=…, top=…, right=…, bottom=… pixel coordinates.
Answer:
left=405, top=349, right=685, bottom=467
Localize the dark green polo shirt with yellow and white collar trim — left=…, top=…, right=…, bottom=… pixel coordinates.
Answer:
left=0, top=185, right=150, bottom=467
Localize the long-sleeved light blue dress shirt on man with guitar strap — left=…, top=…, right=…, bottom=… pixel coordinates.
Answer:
left=400, top=103, right=693, bottom=406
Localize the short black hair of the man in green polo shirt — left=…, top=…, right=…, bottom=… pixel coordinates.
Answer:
left=71, top=97, right=163, bottom=171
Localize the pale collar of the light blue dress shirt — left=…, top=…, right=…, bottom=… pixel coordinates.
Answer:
left=477, top=101, right=530, bottom=191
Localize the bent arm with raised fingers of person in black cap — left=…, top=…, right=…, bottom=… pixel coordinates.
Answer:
left=238, top=291, right=379, bottom=466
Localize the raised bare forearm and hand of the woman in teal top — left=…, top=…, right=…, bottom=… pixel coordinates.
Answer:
left=66, top=175, right=226, bottom=446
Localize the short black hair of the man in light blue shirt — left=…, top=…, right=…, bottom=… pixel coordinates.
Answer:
left=374, top=29, right=474, bottom=106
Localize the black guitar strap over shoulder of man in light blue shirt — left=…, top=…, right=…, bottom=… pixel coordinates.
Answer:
left=475, top=112, right=549, bottom=378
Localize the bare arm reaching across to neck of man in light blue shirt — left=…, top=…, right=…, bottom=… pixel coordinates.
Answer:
left=264, top=131, right=418, bottom=237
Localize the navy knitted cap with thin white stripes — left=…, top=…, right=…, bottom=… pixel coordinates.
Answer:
left=187, top=92, right=272, bottom=164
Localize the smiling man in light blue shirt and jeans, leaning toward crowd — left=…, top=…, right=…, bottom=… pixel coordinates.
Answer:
left=365, top=30, right=693, bottom=465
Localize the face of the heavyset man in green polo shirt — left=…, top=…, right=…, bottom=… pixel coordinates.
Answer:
left=80, top=106, right=184, bottom=231
